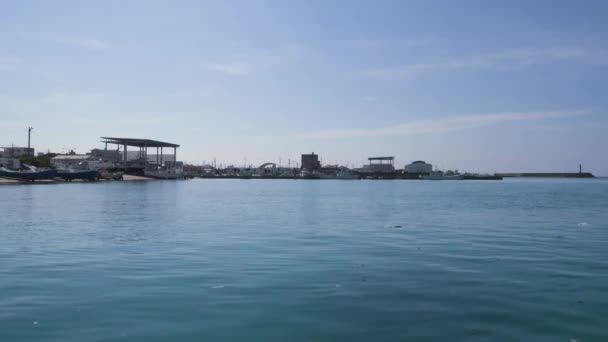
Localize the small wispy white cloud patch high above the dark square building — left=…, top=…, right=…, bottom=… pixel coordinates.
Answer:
left=201, top=44, right=308, bottom=76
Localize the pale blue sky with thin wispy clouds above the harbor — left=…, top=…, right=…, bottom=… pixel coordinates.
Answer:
left=0, top=0, right=608, bottom=175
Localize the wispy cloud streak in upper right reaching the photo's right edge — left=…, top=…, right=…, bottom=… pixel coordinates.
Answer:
left=359, top=47, right=608, bottom=80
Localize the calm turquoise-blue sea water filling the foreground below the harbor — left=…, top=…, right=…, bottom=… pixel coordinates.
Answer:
left=0, top=179, right=608, bottom=342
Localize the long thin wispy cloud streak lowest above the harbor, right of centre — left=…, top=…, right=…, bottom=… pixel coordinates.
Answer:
left=287, top=111, right=589, bottom=139
